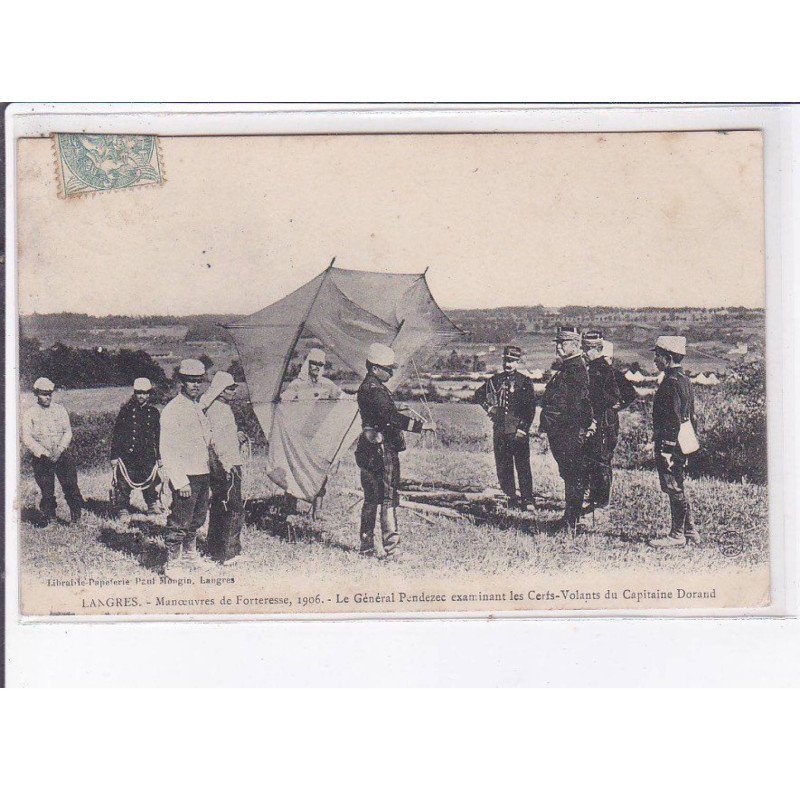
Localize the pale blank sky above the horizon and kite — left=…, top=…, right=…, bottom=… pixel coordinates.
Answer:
left=17, top=131, right=764, bottom=315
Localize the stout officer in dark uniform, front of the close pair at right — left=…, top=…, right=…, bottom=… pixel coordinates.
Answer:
left=539, top=325, right=592, bottom=532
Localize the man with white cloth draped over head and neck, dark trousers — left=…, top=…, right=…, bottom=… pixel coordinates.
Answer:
left=200, top=372, right=247, bottom=565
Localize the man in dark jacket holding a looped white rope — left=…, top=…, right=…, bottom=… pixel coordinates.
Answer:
left=111, top=378, right=161, bottom=517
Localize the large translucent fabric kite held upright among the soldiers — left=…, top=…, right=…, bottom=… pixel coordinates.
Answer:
left=225, top=262, right=460, bottom=502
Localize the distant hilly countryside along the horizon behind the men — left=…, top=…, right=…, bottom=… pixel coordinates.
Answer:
left=20, top=306, right=765, bottom=382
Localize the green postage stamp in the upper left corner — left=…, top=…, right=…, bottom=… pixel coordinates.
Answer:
left=54, top=133, right=165, bottom=198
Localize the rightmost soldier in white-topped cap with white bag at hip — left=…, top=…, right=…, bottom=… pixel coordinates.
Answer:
left=650, top=336, right=700, bottom=547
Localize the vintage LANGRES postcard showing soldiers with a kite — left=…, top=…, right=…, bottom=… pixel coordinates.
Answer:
left=9, top=120, right=771, bottom=618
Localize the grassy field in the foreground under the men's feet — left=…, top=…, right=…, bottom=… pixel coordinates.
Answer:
left=20, top=406, right=768, bottom=610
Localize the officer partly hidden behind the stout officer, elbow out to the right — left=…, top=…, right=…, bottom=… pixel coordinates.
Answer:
left=583, top=331, right=636, bottom=513
